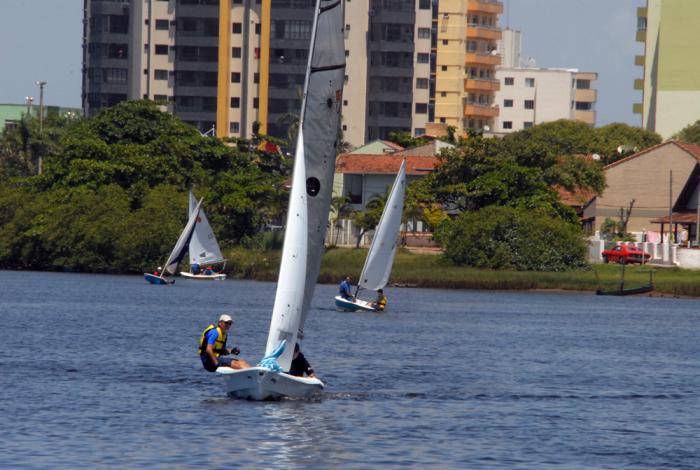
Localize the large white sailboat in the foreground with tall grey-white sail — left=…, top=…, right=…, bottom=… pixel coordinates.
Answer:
left=217, top=0, right=345, bottom=400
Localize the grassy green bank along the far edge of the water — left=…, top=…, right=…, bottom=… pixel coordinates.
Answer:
left=220, top=248, right=700, bottom=297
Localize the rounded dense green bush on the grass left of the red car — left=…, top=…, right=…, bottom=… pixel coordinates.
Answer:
left=436, top=206, right=586, bottom=271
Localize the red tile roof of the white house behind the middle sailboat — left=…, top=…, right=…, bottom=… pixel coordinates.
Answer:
left=335, top=152, right=438, bottom=175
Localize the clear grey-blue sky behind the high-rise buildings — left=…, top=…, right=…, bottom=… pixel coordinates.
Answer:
left=0, top=0, right=646, bottom=126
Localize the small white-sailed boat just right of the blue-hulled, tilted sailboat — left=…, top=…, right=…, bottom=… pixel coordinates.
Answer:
left=180, top=191, right=226, bottom=281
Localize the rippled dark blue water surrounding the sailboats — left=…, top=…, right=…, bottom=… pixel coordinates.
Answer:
left=0, top=271, right=700, bottom=469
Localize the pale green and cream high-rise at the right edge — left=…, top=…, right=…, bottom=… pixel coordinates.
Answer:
left=634, top=0, right=700, bottom=138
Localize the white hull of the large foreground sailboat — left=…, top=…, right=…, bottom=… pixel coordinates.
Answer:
left=216, top=367, right=324, bottom=400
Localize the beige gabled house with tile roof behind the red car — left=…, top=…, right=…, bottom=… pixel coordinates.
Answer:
left=583, top=141, right=700, bottom=240
